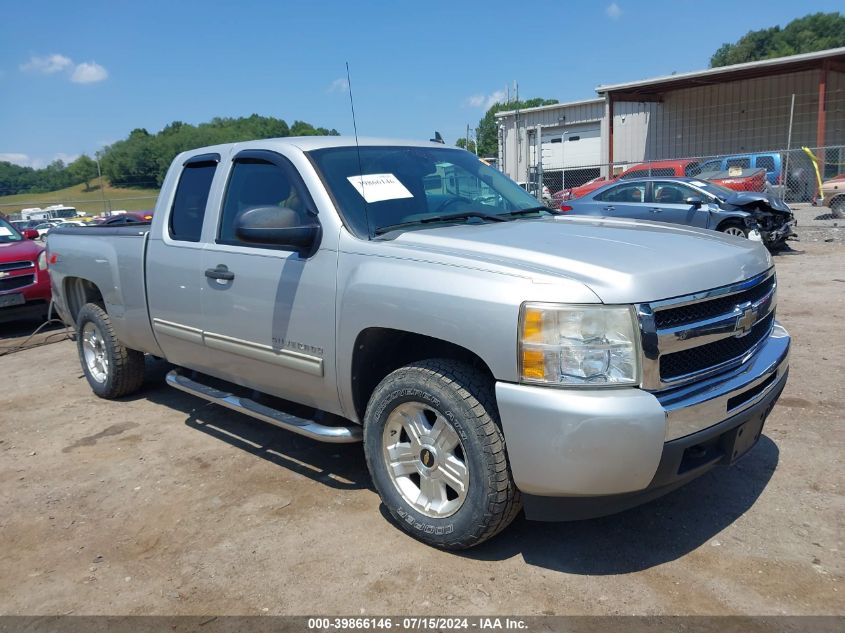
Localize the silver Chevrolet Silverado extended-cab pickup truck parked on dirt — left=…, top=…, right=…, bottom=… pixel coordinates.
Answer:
left=47, top=137, right=790, bottom=549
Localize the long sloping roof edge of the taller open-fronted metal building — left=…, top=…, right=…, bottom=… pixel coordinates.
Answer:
left=596, top=47, right=845, bottom=94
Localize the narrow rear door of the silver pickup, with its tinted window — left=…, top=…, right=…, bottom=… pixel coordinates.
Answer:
left=145, top=154, right=220, bottom=371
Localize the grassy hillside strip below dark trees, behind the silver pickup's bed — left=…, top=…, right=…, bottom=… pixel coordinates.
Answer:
left=0, top=180, right=158, bottom=215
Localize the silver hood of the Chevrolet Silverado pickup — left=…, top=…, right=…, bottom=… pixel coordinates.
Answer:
left=392, top=216, right=772, bottom=303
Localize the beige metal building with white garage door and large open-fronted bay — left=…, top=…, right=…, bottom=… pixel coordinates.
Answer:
left=496, top=48, right=845, bottom=186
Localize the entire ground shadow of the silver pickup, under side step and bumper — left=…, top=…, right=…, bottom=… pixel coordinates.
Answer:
left=134, top=360, right=779, bottom=576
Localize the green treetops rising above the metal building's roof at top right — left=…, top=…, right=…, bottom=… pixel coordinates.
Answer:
left=710, top=11, right=845, bottom=68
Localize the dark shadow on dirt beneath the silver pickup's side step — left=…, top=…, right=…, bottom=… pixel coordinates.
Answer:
left=137, top=359, right=373, bottom=490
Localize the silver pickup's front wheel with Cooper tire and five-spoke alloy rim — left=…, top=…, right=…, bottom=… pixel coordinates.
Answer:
left=364, top=359, right=522, bottom=550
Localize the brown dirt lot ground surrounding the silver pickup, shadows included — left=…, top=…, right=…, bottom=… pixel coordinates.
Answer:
left=0, top=240, right=845, bottom=615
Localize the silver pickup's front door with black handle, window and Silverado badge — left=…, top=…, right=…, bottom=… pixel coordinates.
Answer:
left=202, top=150, right=337, bottom=408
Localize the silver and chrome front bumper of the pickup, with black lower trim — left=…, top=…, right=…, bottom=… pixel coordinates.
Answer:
left=496, top=323, right=790, bottom=521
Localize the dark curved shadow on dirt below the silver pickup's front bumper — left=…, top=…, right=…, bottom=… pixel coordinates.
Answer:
left=460, top=435, right=779, bottom=576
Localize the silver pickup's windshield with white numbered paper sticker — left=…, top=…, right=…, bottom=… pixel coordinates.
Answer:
left=310, top=146, right=540, bottom=237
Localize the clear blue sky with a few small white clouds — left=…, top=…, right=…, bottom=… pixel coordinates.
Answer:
left=0, top=0, right=841, bottom=167
